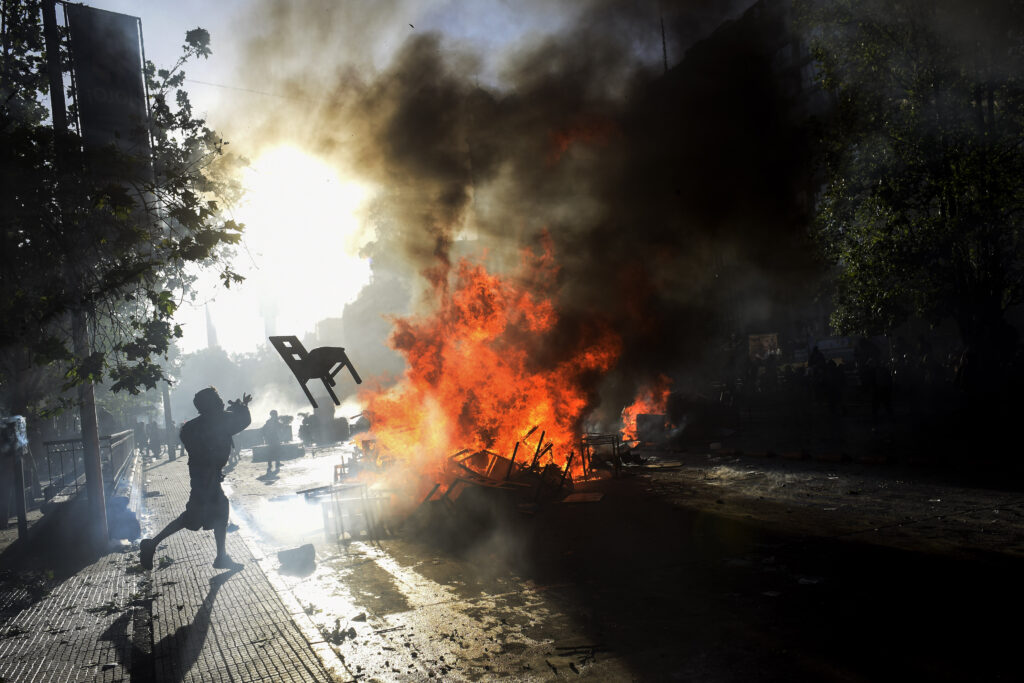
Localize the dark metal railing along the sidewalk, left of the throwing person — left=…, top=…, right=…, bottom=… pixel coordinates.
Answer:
left=40, top=429, right=135, bottom=500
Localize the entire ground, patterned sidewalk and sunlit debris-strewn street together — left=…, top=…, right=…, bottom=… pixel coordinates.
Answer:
left=6, top=440, right=1024, bottom=682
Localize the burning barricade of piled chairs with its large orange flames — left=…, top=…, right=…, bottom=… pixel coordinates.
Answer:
left=276, top=245, right=684, bottom=530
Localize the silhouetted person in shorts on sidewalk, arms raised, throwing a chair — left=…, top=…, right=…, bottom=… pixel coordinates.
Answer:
left=139, top=387, right=252, bottom=569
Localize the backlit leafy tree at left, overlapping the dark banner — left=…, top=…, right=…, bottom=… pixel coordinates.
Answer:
left=0, top=0, right=242, bottom=410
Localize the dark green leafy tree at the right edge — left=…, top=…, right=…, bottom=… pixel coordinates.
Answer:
left=801, top=0, right=1024, bottom=368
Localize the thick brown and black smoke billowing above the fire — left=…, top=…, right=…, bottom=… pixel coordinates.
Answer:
left=222, top=0, right=814, bottom=423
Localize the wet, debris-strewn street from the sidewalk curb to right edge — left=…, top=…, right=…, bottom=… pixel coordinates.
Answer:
left=228, top=451, right=1024, bottom=681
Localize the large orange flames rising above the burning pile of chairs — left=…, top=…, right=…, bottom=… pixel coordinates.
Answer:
left=360, top=243, right=622, bottom=481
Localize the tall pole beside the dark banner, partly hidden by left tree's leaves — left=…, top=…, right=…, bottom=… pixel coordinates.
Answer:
left=43, top=0, right=108, bottom=545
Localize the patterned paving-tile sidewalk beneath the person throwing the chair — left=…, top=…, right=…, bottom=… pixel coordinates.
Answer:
left=0, top=458, right=337, bottom=683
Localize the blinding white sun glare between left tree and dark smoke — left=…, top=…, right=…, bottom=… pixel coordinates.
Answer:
left=184, top=146, right=371, bottom=351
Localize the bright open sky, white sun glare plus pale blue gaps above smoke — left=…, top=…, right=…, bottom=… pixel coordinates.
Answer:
left=72, top=0, right=589, bottom=352
